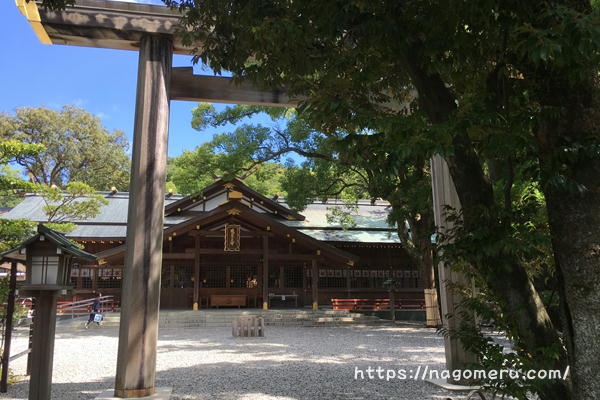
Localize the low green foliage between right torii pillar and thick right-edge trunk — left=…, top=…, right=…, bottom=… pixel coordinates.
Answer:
left=432, top=177, right=565, bottom=400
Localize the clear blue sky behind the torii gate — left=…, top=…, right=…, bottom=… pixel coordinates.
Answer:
left=0, top=0, right=245, bottom=157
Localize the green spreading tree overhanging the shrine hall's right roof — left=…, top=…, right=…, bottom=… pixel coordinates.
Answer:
left=192, top=103, right=435, bottom=296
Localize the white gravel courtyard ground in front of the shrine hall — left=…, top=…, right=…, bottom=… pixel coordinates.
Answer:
left=0, top=325, right=464, bottom=400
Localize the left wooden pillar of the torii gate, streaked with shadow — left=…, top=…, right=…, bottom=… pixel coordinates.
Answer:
left=115, top=35, right=173, bottom=398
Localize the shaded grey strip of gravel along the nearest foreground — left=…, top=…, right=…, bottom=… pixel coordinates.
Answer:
left=0, top=362, right=448, bottom=400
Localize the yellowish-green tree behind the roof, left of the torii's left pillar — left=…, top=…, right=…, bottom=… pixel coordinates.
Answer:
left=0, top=106, right=129, bottom=190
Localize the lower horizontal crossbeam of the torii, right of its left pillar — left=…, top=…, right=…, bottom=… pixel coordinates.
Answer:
left=170, top=67, right=298, bottom=107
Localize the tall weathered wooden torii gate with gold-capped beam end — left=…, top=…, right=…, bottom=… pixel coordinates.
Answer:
left=16, top=0, right=473, bottom=398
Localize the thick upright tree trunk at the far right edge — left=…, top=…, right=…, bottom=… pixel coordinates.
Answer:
left=536, top=72, right=600, bottom=400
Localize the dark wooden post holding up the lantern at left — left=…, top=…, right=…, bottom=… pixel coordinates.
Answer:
left=29, top=291, right=57, bottom=400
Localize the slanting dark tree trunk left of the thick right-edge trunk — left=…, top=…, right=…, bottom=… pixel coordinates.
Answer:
left=404, top=45, right=570, bottom=400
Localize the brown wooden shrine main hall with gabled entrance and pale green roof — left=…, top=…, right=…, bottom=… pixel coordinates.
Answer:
left=2, top=179, right=423, bottom=309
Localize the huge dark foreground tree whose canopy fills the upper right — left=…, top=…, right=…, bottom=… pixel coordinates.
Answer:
left=161, top=0, right=600, bottom=399
